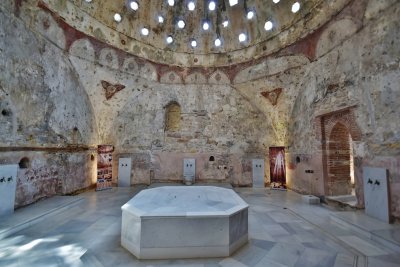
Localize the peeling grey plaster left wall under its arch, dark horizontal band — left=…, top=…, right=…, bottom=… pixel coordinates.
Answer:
left=0, top=3, right=97, bottom=207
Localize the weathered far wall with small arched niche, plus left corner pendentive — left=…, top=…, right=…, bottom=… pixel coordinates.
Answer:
left=70, top=50, right=275, bottom=185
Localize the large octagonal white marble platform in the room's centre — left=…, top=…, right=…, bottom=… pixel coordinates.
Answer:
left=121, top=186, right=249, bottom=259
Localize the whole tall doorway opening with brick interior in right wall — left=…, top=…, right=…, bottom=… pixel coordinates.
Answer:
left=316, top=106, right=364, bottom=204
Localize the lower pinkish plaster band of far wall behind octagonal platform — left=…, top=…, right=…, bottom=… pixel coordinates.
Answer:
left=114, top=150, right=267, bottom=186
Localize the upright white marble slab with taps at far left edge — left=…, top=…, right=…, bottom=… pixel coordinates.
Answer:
left=0, top=165, right=18, bottom=216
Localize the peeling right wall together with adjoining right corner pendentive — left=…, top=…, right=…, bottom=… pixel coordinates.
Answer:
left=227, top=0, right=400, bottom=218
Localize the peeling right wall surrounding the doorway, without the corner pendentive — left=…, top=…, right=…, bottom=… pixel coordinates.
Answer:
left=287, top=1, right=400, bottom=218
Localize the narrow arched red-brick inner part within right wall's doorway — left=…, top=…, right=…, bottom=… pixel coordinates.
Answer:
left=327, top=122, right=353, bottom=196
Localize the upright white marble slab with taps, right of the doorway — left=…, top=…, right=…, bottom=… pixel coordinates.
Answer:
left=363, top=167, right=390, bottom=223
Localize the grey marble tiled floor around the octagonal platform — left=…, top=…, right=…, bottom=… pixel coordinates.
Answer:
left=0, top=188, right=400, bottom=267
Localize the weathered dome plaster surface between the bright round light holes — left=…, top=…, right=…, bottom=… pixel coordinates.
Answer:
left=34, top=0, right=351, bottom=67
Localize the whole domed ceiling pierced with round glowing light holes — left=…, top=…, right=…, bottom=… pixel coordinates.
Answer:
left=43, top=0, right=349, bottom=67
